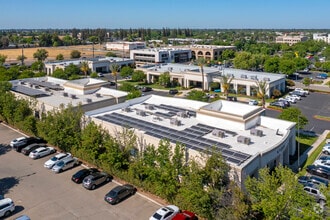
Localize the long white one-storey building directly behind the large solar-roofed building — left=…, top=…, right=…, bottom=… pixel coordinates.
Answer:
left=137, top=63, right=285, bottom=97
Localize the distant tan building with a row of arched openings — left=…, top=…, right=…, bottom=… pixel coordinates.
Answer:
left=189, top=45, right=236, bottom=60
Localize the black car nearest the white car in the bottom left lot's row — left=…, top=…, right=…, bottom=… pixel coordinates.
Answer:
left=104, top=184, right=136, bottom=205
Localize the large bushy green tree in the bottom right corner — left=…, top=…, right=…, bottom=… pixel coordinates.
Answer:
left=245, top=166, right=318, bottom=219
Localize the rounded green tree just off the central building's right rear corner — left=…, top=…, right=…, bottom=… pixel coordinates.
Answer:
left=278, top=107, right=308, bottom=130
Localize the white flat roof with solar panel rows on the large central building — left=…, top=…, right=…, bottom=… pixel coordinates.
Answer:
left=85, top=95, right=295, bottom=166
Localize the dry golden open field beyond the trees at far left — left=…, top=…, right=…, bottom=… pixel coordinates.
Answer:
left=0, top=45, right=108, bottom=62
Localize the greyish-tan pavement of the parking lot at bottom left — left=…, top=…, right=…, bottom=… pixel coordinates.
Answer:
left=0, top=124, right=160, bottom=219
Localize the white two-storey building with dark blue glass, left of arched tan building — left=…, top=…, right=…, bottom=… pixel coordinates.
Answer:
left=130, top=48, right=192, bottom=63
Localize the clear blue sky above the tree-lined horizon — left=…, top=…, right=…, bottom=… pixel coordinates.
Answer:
left=0, top=0, right=330, bottom=30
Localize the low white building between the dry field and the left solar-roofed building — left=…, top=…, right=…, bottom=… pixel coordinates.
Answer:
left=45, top=57, right=134, bottom=76
